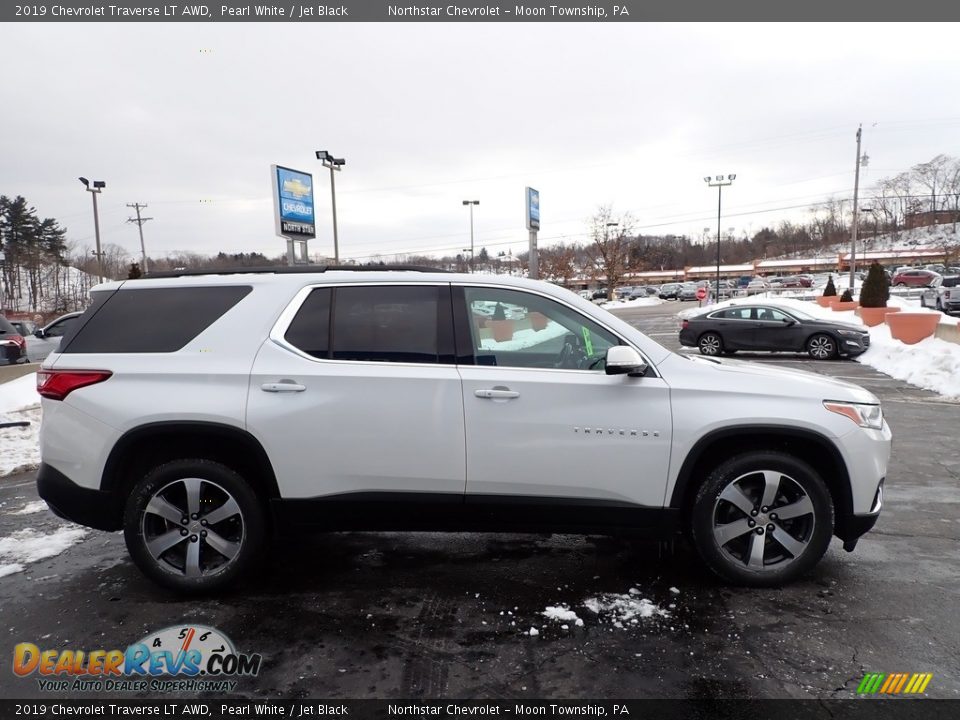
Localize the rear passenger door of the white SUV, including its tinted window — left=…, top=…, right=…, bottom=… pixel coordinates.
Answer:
left=247, top=286, right=466, bottom=498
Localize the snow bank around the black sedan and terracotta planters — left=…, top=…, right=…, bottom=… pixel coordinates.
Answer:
left=677, top=297, right=960, bottom=400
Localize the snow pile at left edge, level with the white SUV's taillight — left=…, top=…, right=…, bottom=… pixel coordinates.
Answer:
left=0, top=373, right=41, bottom=477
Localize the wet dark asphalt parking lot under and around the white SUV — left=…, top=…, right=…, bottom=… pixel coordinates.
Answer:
left=0, top=303, right=960, bottom=699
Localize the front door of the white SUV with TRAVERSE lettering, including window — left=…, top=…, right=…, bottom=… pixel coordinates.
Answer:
left=454, top=287, right=672, bottom=507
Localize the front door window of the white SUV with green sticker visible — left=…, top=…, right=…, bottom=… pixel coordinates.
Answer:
left=465, top=287, right=622, bottom=372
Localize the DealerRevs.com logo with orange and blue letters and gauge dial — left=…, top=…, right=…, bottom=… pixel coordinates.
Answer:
left=13, top=625, right=262, bottom=692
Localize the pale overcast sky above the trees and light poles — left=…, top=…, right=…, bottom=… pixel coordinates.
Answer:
left=0, top=22, right=960, bottom=261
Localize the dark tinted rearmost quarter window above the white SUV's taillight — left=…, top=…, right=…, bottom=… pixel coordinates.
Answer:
left=60, top=285, right=252, bottom=353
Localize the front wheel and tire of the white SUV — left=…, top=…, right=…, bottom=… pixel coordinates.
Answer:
left=690, top=451, right=834, bottom=587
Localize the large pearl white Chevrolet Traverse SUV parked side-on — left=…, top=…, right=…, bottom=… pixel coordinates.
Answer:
left=37, top=268, right=890, bottom=591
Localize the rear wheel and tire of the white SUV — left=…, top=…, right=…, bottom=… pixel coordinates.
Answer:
left=123, top=458, right=265, bottom=594
